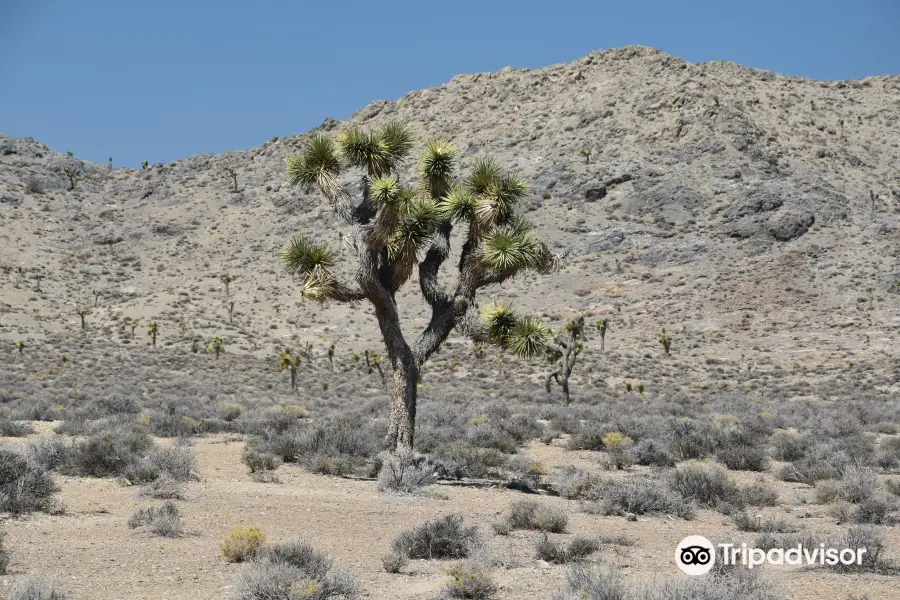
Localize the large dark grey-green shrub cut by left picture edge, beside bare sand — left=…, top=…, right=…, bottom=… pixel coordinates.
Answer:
left=0, top=448, right=59, bottom=515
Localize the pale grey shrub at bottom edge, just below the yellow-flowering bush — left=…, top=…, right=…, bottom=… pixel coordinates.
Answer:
left=234, top=541, right=360, bottom=600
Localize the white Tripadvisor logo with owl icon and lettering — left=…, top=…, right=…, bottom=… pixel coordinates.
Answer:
left=675, top=535, right=867, bottom=575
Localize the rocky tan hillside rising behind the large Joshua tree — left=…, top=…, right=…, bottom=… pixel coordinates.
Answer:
left=0, top=47, right=900, bottom=372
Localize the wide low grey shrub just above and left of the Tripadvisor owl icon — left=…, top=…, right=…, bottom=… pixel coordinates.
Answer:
left=585, top=478, right=695, bottom=520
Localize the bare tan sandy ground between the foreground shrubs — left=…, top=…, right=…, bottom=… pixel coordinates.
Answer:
left=0, top=436, right=900, bottom=600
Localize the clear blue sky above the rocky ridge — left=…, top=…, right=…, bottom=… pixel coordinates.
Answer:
left=0, top=0, right=900, bottom=167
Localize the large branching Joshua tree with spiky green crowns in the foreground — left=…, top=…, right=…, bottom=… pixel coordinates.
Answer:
left=282, top=122, right=558, bottom=451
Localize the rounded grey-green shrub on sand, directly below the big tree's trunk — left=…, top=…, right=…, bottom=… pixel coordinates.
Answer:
left=392, top=515, right=480, bottom=559
